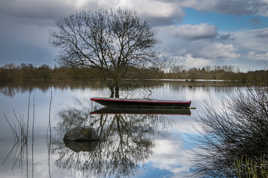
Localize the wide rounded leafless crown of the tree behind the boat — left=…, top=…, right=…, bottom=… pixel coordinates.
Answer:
left=52, top=9, right=156, bottom=96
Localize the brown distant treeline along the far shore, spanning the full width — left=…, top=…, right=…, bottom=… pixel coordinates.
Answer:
left=0, top=64, right=268, bottom=85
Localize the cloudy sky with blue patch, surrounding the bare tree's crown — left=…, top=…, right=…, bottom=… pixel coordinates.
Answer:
left=0, top=0, right=268, bottom=70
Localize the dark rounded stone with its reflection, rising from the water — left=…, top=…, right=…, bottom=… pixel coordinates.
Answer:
left=63, top=127, right=100, bottom=152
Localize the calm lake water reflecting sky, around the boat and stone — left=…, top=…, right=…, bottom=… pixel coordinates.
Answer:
left=0, top=82, right=241, bottom=178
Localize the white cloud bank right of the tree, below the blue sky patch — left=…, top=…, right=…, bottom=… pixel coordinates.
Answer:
left=155, top=25, right=268, bottom=71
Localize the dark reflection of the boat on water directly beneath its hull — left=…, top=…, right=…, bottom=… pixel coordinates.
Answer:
left=90, top=107, right=191, bottom=115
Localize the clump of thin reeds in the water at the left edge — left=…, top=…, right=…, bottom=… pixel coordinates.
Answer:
left=2, top=94, right=35, bottom=177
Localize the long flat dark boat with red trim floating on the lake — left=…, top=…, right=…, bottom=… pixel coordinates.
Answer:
left=91, top=97, right=191, bottom=108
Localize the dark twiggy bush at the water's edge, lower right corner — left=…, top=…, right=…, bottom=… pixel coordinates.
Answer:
left=196, top=88, right=268, bottom=177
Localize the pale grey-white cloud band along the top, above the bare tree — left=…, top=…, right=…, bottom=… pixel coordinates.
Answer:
left=0, top=0, right=184, bottom=24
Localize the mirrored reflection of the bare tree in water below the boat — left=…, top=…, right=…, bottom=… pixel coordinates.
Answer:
left=54, top=103, right=170, bottom=177
